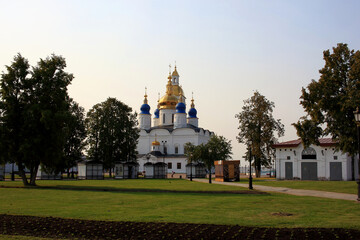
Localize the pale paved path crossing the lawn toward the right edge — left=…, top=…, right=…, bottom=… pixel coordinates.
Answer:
left=193, top=179, right=357, bottom=201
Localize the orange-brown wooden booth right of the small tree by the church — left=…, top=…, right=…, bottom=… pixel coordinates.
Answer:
left=214, top=160, right=240, bottom=182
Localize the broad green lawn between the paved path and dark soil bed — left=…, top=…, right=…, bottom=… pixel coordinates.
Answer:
left=0, top=179, right=360, bottom=229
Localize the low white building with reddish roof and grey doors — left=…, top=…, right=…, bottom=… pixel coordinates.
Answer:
left=273, top=138, right=357, bottom=181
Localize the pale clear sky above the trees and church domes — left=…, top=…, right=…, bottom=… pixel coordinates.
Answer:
left=0, top=0, right=360, bottom=165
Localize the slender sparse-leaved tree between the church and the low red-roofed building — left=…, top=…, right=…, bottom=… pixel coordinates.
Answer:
left=235, top=91, right=284, bottom=177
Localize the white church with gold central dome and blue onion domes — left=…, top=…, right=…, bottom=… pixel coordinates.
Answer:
left=137, top=66, right=213, bottom=173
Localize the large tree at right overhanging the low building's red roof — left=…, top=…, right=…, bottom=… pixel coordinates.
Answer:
left=293, top=43, right=360, bottom=179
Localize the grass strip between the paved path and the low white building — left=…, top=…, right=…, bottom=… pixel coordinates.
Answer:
left=240, top=178, right=357, bottom=194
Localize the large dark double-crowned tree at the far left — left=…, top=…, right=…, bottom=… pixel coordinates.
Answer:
left=0, top=54, right=73, bottom=185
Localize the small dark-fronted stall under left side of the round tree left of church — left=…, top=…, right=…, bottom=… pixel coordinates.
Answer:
left=78, top=160, right=104, bottom=180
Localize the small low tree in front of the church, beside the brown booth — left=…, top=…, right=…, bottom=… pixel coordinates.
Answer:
left=193, top=135, right=232, bottom=183
